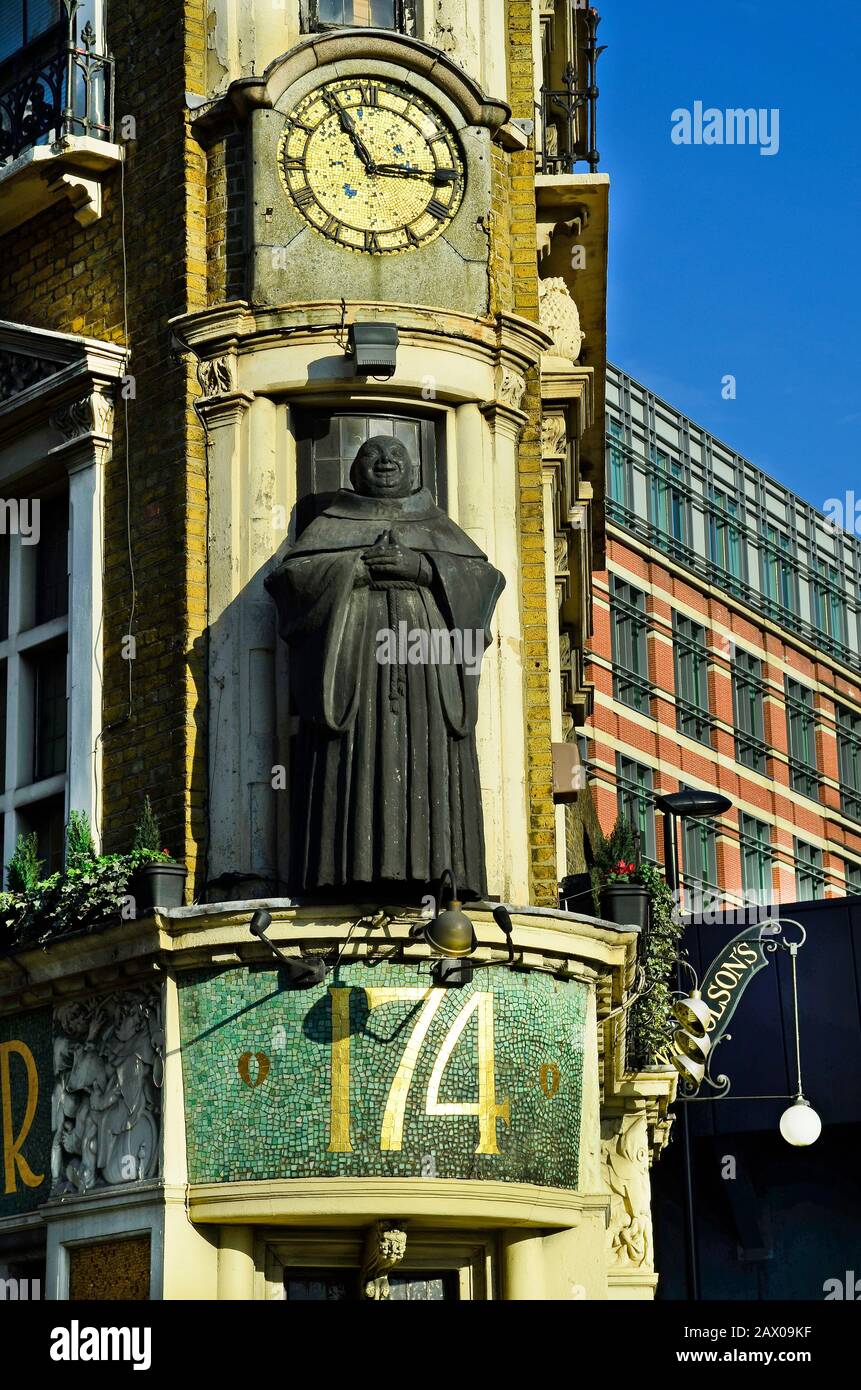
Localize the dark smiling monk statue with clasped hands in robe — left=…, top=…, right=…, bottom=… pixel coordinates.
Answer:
left=266, top=435, right=505, bottom=902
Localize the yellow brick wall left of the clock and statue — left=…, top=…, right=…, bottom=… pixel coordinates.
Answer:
left=0, top=0, right=206, bottom=889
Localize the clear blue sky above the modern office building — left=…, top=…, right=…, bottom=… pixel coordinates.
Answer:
left=598, top=0, right=861, bottom=506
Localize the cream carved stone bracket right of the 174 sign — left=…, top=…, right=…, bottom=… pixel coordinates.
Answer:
left=601, top=1115, right=654, bottom=1272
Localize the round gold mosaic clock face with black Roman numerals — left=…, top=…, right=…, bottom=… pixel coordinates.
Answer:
left=278, top=78, right=465, bottom=256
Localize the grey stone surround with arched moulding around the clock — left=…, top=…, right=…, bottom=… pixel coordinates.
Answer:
left=196, top=31, right=520, bottom=314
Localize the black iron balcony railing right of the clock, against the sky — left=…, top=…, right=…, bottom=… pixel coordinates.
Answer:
left=536, top=7, right=606, bottom=174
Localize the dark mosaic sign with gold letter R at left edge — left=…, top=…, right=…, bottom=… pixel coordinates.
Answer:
left=0, top=1009, right=51, bottom=1218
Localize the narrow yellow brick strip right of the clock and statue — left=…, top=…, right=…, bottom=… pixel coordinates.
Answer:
left=501, top=0, right=558, bottom=905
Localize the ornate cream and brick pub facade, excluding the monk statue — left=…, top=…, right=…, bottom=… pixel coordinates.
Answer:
left=0, top=0, right=675, bottom=1300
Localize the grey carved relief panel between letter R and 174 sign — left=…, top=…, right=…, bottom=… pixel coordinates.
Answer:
left=51, top=984, right=164, bottom=1197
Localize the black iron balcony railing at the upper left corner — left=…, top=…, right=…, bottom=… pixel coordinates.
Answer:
left=0, top=0, right=114, bottom=168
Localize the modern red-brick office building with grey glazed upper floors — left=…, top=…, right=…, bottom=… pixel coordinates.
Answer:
left=584, top=366, right=861, bottom=908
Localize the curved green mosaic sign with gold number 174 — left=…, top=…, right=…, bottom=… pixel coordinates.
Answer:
left=179, top=963, right=586, bottom=1188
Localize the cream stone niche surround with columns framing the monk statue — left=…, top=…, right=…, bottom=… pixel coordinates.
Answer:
left=172, top=302, right=549, bottom=902
